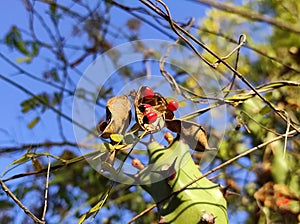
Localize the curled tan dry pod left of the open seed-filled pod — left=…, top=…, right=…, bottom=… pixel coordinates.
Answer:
left=100, top=95, right=131, bottom=138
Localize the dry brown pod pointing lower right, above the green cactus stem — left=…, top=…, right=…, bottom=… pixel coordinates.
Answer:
left=165, top=119, right=210, bottom=151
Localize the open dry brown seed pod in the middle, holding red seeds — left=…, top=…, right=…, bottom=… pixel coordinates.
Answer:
left=134, top=86, right=174, bottom=133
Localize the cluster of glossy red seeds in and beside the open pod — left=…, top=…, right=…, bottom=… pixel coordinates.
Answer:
left=138, top=86, right=179, bottom=124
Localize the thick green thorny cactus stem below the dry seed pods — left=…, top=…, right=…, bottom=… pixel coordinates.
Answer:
left=139, top=141, right=228, bottom=224
